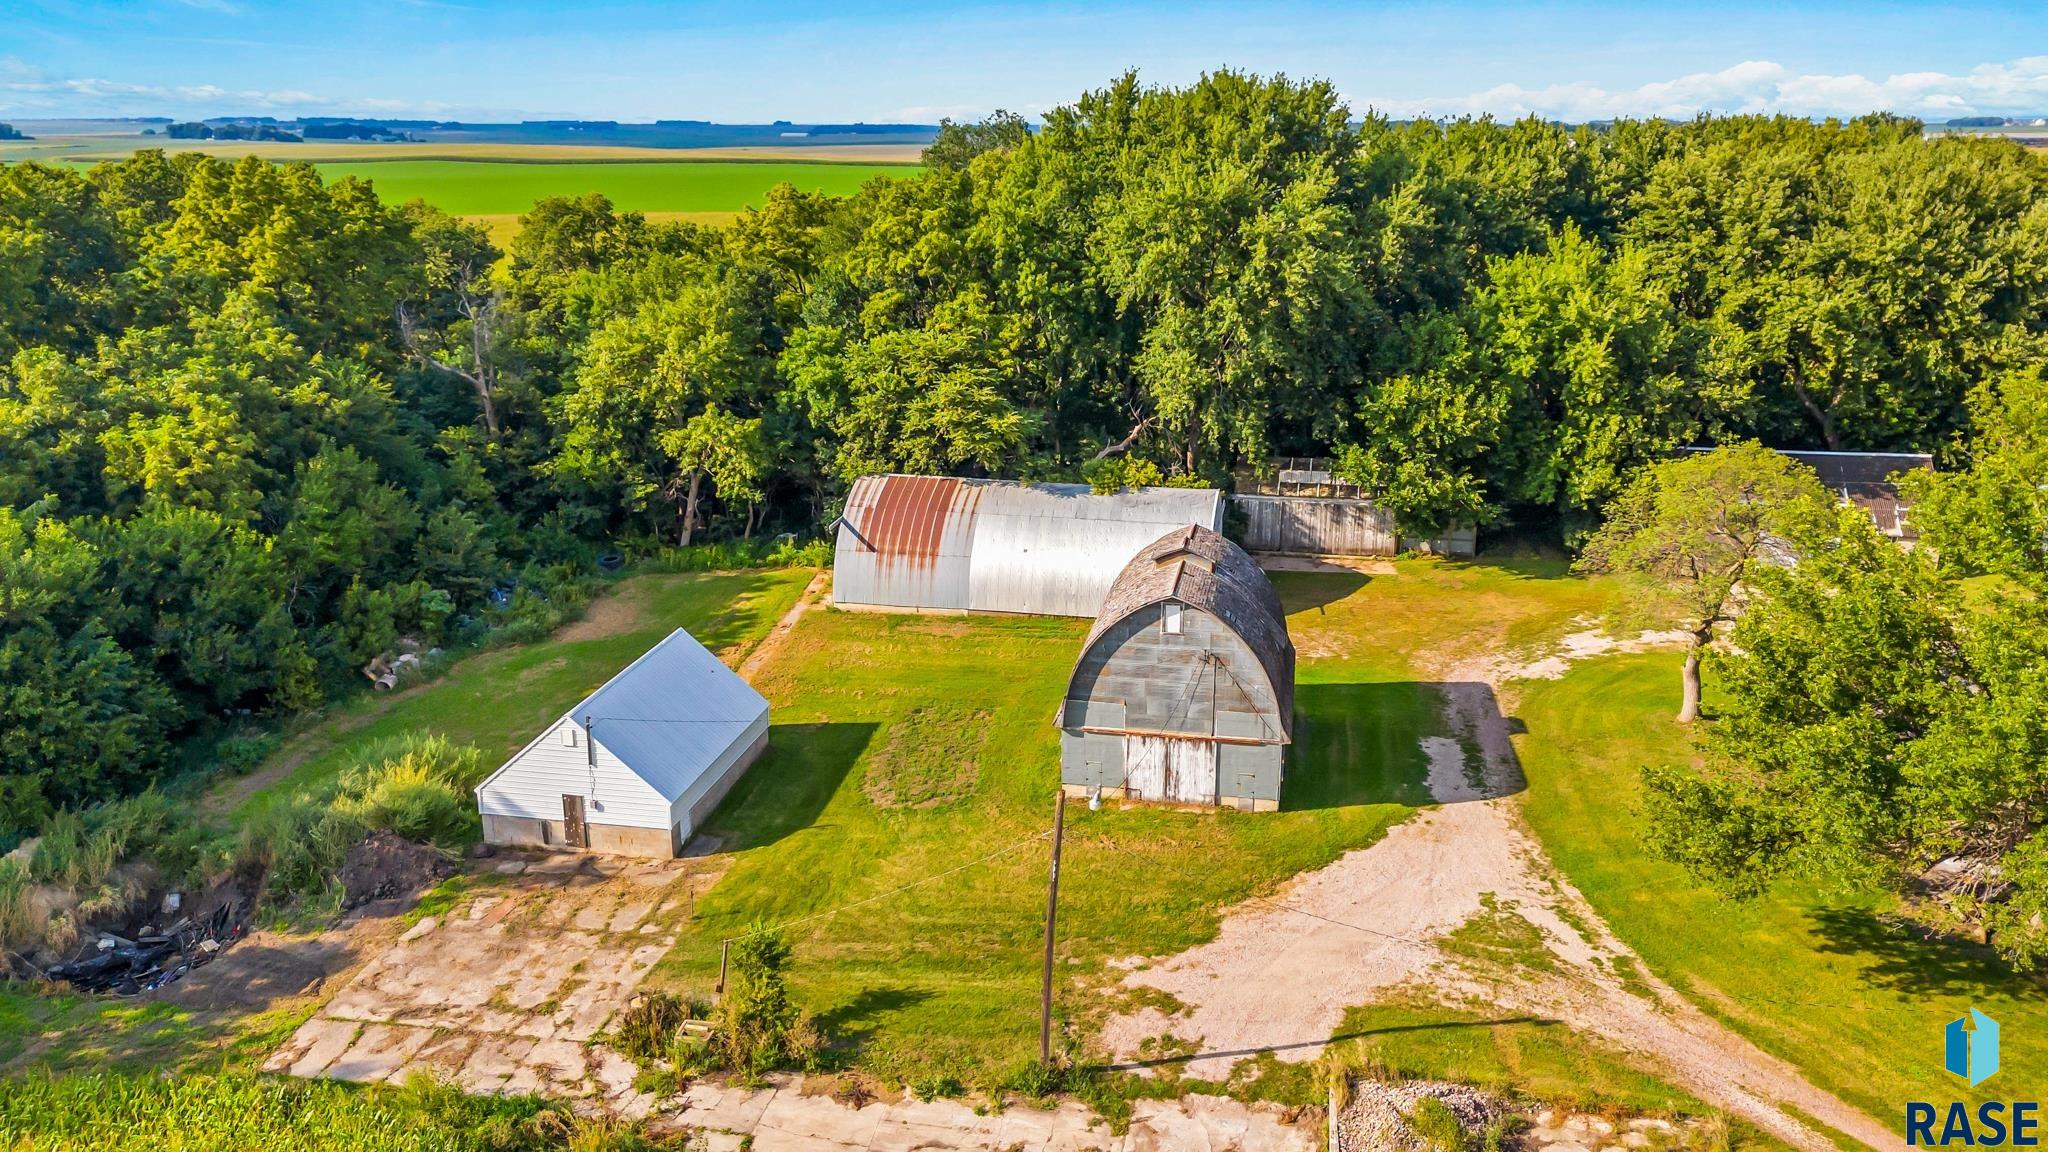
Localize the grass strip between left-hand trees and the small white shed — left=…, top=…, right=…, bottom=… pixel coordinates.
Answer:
left=213, top=568, right=811, bottom=820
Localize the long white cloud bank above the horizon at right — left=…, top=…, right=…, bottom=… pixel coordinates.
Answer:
left=1352, top=55, right=2048, bottom=121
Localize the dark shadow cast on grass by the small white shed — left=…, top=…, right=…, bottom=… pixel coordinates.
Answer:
left=705, top=724, right=879, bottom=851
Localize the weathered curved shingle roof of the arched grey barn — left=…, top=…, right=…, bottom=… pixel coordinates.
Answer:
left=1069, top=525, right=1294, bottom=740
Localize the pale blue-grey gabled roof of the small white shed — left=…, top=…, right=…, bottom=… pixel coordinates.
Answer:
left=479, top=627, right=768, bottom=804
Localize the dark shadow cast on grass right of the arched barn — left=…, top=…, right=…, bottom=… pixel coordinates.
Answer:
left=1280, top=681, right=1526, bottom=812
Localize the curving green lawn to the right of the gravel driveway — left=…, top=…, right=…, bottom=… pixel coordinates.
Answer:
left=1516, top=654, right=2048, bottom=1132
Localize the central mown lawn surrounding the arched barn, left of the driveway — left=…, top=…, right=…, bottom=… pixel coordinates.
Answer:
left=655, top=562, right=1606, bottom=1082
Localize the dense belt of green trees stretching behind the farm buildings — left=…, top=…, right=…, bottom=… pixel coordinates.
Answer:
left=0, top=72, right=2048, bottom=834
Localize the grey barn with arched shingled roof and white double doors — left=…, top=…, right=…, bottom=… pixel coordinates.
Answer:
left=1057, top=527, right=1294, bottom=812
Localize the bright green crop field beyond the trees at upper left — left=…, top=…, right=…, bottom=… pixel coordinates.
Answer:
left=315, top=160, right=918, bottom=215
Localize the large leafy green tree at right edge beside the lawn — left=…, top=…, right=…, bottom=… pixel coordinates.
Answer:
left=1645, top=371, right=2048, bottom=968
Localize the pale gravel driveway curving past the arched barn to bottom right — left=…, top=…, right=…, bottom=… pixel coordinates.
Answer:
left=1104, top=631, right=1905, bottom=1152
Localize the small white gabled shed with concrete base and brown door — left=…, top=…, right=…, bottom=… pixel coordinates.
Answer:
left=477, top=627, right=768, bottom=857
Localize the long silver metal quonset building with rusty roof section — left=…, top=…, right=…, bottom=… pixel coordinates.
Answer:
left=831, top=476, right=1223, bottom=617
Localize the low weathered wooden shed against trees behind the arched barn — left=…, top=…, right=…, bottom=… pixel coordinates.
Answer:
left=1231, top=457, right=1479, bottom=556
